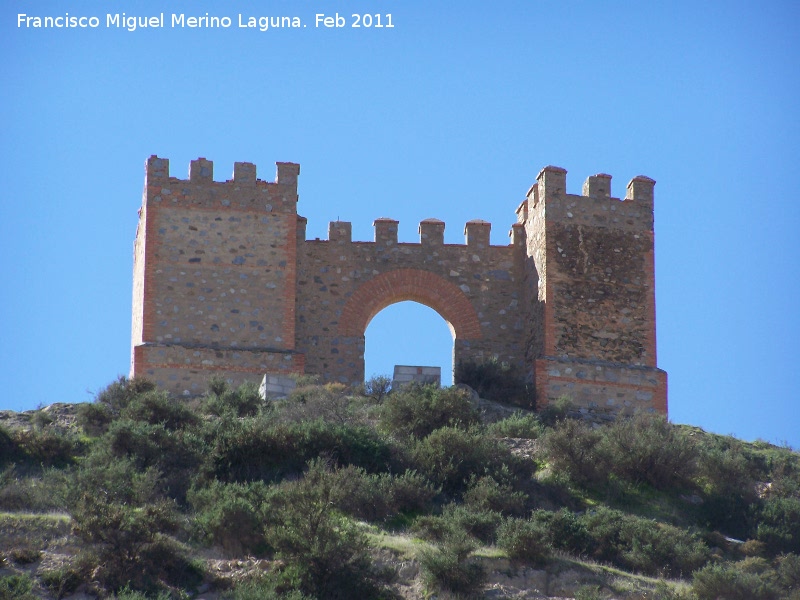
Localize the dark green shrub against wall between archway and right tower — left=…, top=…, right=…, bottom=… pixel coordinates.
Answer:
left=454, top=359, right=534, bottom=408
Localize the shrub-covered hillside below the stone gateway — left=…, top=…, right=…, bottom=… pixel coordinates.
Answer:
left=0, top=378, right=800, bottom=600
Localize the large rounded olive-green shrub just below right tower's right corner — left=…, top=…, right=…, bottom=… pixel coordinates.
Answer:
left=602, top=413, right=698, bottom=490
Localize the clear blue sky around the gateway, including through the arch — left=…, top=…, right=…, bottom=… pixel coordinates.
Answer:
left=0, top=0, right=800, bottom=448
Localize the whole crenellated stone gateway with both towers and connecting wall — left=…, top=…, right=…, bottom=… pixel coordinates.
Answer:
left=131, top=157, right=666, bottom=412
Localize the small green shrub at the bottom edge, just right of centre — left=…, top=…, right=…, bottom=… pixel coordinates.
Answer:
left=419, top=532, right=487, bottom=598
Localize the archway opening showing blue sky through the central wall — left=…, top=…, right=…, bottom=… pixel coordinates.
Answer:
left=364, top=301, right=454, bottom=385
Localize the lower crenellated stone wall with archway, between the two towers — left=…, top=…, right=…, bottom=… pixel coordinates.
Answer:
left=297, top=219, right=524, bottom=383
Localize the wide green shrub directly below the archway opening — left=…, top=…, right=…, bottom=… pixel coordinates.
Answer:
left=381, top=384, right=479, bottom=438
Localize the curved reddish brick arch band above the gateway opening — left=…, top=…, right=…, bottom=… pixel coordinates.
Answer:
left=339, top=269, right=483, bottom=339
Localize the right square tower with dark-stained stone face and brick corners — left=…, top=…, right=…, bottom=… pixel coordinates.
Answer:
left=520, top=167, right=667, bottom=414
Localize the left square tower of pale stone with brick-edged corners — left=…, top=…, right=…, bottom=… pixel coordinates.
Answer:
left=131, top=156, right=303, bottom=396
